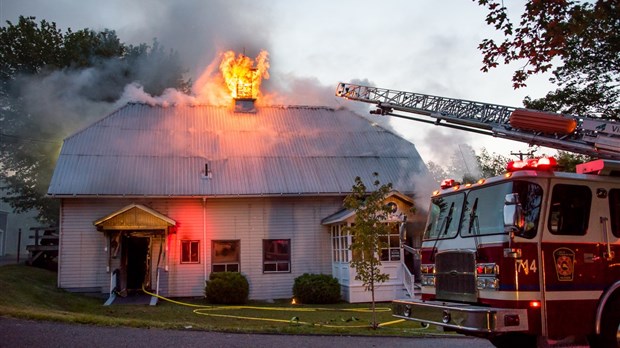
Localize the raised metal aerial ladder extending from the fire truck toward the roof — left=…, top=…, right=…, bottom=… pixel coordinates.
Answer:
left=336, top=82, right=620, bottom=160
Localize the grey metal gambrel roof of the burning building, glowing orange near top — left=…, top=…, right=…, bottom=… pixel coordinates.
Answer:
left=48, top=104, right=427, bottom=197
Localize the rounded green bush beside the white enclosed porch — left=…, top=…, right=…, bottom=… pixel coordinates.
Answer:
left=293, top=273, right=340, bottom=303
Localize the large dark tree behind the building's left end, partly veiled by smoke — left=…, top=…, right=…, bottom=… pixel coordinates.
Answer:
left=0, top=16, right=189, bottom=224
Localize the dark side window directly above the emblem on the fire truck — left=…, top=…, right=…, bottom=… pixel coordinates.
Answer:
left=547, top=184, right=592, bottom=236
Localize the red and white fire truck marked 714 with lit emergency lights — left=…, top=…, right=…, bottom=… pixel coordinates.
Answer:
left=393, top=158, right=620, bottom=347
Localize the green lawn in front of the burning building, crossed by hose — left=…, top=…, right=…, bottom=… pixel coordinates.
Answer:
left=0, top=265, right=441, bottom=336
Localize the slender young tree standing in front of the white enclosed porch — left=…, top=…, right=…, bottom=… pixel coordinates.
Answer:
left=344, top=173, right=392, bottom=329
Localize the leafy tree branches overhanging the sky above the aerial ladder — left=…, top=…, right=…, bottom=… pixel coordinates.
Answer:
left=474, top=0, right=620, bottom=119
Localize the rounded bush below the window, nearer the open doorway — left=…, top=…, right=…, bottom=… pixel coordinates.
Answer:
left=205, top=272, right=250, bottom=304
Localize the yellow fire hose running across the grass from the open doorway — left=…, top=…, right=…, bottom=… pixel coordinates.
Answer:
left=142, top=286, right=426, bottom=330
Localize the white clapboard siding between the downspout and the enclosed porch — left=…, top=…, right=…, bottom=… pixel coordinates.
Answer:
left=206, top=197, right=342, bottom=299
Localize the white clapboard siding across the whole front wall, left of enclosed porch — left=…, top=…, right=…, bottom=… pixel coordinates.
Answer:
left=59, top=197, right=343, bottom=299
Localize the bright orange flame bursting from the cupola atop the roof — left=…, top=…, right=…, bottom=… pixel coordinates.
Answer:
left=220, top=50, right=269, bottom=99
